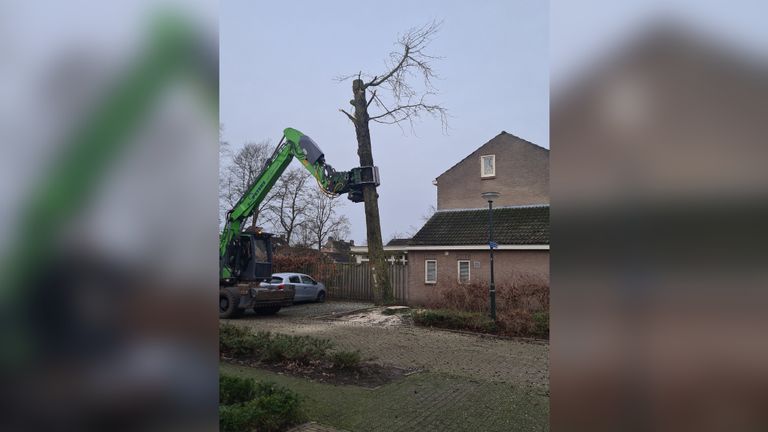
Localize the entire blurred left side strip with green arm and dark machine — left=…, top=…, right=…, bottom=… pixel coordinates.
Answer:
left=0, top=2, right=218, bottom=431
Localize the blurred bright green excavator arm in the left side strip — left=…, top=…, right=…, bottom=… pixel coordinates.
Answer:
left=0, top=13, right=218, bottom=365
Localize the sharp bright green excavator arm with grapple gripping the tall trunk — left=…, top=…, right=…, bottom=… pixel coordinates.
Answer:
left=219, top=128, right=379, bottom=279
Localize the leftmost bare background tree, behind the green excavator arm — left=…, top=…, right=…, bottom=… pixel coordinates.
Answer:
left=220, top=140, right=275, bottom=228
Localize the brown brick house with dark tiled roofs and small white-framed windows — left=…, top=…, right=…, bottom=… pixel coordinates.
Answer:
left=405, top=131, right=549, bottom=304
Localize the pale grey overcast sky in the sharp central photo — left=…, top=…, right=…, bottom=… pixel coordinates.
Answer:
left=219, top=0, right=549, bottom=244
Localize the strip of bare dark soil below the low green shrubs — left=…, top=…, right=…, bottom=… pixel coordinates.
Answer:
left=222, top=358, right=417, bottom=388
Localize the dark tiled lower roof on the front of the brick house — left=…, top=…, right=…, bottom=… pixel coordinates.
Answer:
left=409, top=205, right=549, bottom=246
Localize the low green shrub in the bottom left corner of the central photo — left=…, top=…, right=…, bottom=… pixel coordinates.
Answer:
left=219, top=375, right=303, bottom=432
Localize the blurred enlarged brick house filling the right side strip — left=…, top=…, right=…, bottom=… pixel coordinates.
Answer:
left=551, top=2, right=768, bottom=431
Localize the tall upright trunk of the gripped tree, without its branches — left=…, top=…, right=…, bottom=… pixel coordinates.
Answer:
left=350, top=79, right=394, bottom=305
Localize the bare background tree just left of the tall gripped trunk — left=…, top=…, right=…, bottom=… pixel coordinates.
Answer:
left=300, top=188, right=349, bottom=250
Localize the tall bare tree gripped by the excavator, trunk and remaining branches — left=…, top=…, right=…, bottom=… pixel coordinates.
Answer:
left=338, top=21, right=447, bottom=304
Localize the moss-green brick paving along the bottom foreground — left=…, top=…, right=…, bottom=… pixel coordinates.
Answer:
left=221, top=364, right=549, bottom=432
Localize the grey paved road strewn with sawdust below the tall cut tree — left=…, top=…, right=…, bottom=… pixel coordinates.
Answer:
left=225, top=302, right=549, bottom=394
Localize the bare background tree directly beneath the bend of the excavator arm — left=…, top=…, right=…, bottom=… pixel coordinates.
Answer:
left=266, top=168, right=314, bottom=245
